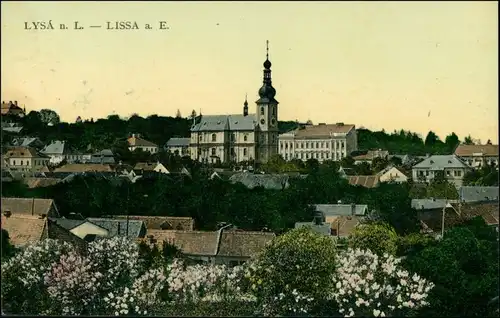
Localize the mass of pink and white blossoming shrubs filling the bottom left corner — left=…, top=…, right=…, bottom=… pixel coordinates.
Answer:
left=2, top=237, right=166, bottom=315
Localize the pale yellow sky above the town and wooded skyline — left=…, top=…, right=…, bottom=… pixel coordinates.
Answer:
left=0, top=1, right=498, bottom=143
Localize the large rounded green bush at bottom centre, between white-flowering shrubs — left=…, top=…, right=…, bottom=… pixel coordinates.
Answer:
left=246, top=227, right=336, bottom=315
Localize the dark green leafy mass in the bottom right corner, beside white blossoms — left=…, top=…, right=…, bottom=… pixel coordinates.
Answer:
left=405, top=219, right=499, bottom=317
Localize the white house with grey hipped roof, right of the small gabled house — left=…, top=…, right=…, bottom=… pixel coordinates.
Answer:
left=412, top=155, right=471, bottom=187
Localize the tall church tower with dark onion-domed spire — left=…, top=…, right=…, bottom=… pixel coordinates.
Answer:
left=255, top=41, right=279, bottom=163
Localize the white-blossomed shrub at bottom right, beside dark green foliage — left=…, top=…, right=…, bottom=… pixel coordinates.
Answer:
left=332, top=249, right=434, bottom=317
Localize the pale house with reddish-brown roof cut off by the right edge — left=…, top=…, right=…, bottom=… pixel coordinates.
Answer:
left=455, top=145, right=498, bottom=168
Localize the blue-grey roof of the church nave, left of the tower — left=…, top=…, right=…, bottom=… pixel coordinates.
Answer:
left=191, top=114, right=257, bottom=131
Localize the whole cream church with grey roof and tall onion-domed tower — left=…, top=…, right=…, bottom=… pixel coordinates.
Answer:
left=189, top=41, right=279, bottom=163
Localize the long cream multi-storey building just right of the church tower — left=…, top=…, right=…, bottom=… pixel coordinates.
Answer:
left=279, top=123, right=358, bottom=162
